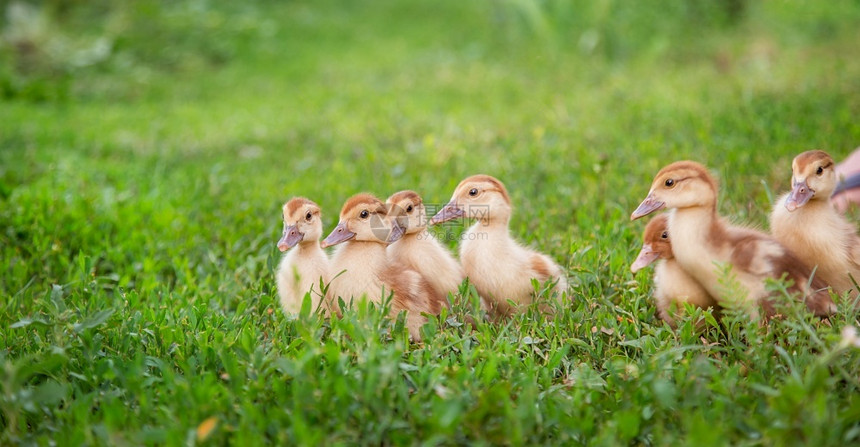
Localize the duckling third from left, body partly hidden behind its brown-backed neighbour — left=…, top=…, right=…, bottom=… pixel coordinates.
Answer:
left=385, top=191, right=465, bottom=296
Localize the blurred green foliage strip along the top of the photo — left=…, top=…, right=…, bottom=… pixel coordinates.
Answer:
left=0, top=0, right=860, bottom=101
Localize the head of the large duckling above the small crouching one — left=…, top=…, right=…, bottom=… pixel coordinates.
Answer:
left=630, top=161, right=717, bottom=220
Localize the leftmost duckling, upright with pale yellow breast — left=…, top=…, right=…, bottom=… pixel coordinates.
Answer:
left=275, top=197, right=329, bottom=314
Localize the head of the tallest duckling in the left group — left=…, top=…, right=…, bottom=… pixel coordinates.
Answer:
left=430, top=174, right=511, bottom=225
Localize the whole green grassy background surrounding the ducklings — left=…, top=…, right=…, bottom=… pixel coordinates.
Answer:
left=0, top=0, right=860, bottom=446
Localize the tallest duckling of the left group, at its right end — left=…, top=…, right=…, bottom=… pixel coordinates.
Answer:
left=430, top=175, right=567, bottom=317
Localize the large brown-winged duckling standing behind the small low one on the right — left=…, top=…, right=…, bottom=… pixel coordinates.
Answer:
left=630, top=161, right=835, bottom=317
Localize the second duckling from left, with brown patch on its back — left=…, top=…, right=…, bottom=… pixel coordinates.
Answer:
left=322, top=193, right=447, bottom=341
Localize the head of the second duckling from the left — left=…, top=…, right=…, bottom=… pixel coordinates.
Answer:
left=321, top=193, right=404, bottom=248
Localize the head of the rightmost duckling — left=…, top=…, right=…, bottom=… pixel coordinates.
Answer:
left=785, top=150, right=836, bottom=211
